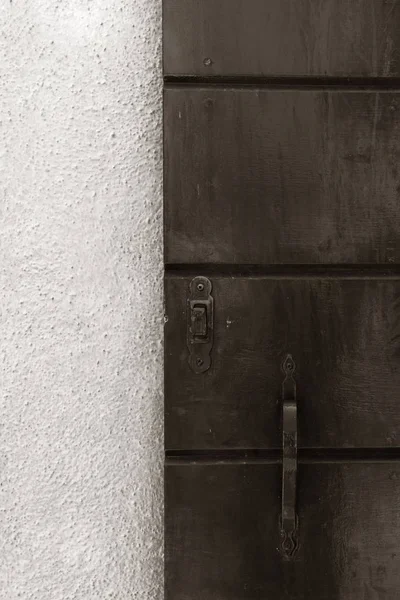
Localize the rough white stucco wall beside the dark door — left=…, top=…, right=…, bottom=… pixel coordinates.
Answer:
left=0, top=0, right=163, bottom=600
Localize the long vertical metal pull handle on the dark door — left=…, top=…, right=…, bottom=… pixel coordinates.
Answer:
left=281, top=354, right=298, bottom=558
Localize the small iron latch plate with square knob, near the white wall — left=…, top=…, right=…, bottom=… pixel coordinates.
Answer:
left=187, top=277, right=214, bottom=373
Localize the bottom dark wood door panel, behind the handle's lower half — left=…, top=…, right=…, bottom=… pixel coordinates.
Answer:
left=166, top=463, right=400, bottom=600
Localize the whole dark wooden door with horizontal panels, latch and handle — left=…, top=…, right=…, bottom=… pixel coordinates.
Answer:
left=164, top=0, right=400, bottom=600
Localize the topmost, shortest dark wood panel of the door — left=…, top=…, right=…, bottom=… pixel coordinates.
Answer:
left=164, top=0, right=400, bottom=77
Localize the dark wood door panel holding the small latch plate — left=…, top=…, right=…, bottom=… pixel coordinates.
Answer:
left=165, top=277, right=400, bottom=449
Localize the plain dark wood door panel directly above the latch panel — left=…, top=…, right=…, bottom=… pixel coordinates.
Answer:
left=165, top=89, right=400, bottom=264
